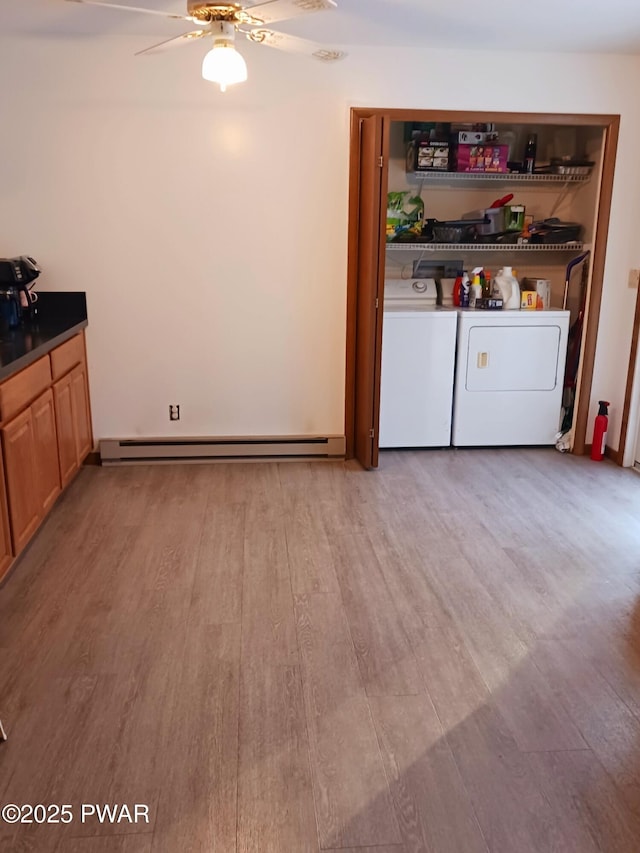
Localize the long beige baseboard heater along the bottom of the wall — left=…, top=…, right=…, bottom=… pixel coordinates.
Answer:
left=100, top=435, right=346, bottom=465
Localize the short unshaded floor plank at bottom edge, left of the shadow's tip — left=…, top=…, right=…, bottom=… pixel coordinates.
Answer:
left=237, top=664, right=319, bottom=853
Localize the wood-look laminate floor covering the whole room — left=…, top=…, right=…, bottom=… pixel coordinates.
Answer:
left=0, top=449, right=640, bottom=853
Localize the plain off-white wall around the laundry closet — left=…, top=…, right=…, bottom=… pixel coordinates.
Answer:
left=0, top=38, right=640, bottom=445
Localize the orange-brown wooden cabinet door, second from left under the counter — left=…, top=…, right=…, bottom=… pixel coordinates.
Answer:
left=2, top=409, right=41, bottom=556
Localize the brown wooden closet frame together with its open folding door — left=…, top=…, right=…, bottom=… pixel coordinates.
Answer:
left=345, top=108, right=620, bottom=469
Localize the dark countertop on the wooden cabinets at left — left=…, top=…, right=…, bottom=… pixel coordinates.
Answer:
left=0, top=292, right=88, bottom=381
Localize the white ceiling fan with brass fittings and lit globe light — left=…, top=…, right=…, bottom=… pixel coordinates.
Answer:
left=63, top=0, right=346, bottom=92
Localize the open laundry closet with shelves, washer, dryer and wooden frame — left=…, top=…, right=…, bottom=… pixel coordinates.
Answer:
left=346, top=110, right=618, bottom=467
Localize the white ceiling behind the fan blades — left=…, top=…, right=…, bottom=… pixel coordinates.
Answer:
left=0, top=0, right=640, bottom=54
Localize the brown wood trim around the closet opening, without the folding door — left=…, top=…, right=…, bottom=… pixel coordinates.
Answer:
left=345, top=107, right=620, bottom=458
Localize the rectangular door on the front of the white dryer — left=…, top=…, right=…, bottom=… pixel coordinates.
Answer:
left=465, top=324, right=561, bottom=392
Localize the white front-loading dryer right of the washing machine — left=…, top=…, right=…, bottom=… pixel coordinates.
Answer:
left=451, top=310, right=569, bottom=447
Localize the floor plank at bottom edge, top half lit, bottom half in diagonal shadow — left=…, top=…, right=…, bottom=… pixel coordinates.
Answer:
left=370, top=696, right=488, bottom=853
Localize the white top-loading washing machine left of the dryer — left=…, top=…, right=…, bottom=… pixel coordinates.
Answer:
left=379, top=279, right=458, bottom=448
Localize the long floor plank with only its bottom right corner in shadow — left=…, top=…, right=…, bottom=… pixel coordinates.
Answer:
left=296, top=594, right=401, bottom=848
